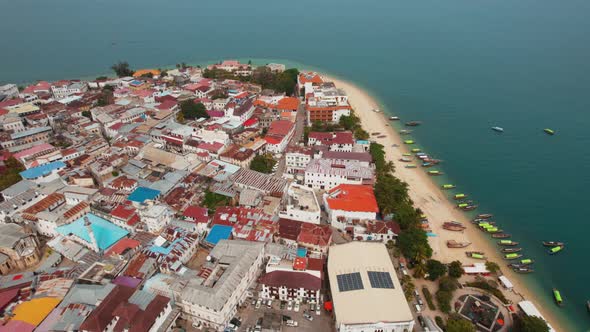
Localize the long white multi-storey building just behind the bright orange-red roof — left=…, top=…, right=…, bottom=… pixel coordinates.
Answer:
left=304, top=159, right=374, bottom=190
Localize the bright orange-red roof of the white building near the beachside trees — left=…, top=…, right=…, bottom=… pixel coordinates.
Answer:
left=326, top=184, right=379, bottom=213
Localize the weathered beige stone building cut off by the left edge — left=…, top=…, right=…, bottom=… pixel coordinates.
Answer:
left=0, top=224, right=41, bottom=275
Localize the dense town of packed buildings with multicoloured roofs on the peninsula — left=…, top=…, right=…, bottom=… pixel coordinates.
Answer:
left=0, top=60, right=556, bottom=332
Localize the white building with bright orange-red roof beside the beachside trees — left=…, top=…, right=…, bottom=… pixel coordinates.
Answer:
left=324, top=184, right=379, bottom=230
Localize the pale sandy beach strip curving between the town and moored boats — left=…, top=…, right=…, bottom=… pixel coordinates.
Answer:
left=322, top=75, right=566, bottom=331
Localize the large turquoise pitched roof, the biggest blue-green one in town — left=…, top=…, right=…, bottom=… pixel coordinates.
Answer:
left=57, top=213, right=129, bottom=250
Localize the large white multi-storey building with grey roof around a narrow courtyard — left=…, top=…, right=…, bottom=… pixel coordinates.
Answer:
left=173, top=240, right=265, bottom=331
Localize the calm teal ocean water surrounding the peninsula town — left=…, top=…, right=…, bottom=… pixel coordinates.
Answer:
left=0, top=0, right=590, bottom=331
